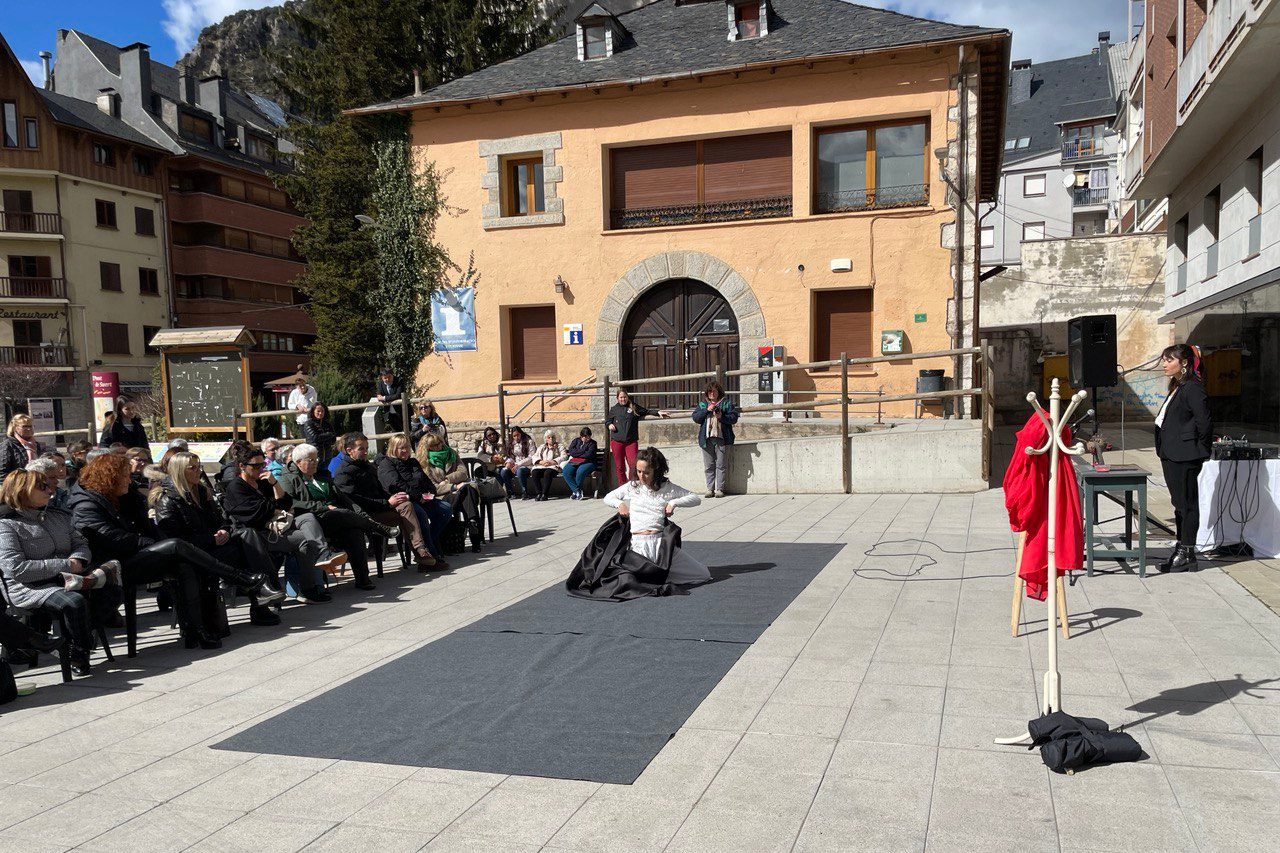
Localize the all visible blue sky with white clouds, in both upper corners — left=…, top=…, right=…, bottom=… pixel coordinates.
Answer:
left=0, top=0, right=1140, bottom=83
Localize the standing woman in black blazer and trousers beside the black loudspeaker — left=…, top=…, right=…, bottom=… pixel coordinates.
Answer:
left=1156, top=343, right=1213, bottom=571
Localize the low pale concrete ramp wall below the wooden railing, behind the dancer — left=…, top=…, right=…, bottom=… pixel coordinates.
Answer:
left=662, top=420, right=987, bottom=494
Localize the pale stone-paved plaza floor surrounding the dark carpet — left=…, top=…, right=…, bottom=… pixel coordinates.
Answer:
left=0, top=491, right=1280, bottom=853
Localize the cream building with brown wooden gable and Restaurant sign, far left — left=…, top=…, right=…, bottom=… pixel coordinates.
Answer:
left=0, top=36, right=170, bottom=429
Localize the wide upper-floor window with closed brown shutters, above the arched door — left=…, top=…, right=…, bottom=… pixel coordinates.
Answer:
left=609, top=131, right=791, bottom=228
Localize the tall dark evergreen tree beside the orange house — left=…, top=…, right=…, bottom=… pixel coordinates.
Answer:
left=276, top=0, right=554, bottom=379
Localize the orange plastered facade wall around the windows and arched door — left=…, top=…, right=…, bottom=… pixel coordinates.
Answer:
left=412, top=43, right=977, bottom=419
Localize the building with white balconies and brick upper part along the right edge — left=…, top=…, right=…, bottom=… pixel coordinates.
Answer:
left=1126, top=0, right=1280, bottom=442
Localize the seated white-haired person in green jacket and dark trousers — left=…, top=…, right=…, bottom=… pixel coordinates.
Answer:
left=279, top=444, right=399, bottom=589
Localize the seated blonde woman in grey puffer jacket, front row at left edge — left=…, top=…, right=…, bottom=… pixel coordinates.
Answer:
left=0, top=471, right=120, bottom=675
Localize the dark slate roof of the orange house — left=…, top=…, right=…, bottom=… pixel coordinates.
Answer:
left=352, top=0, right=1007, bottom=113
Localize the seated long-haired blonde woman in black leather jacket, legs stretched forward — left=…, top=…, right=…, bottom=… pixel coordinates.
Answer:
left=148, top=451, right=284, bottom=625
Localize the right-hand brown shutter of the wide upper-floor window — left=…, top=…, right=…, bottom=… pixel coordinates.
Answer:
left=703, top=131, right=791, bottom=201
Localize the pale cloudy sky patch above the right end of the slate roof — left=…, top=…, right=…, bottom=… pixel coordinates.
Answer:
left=858, top=0, right=1140, bottom=63
